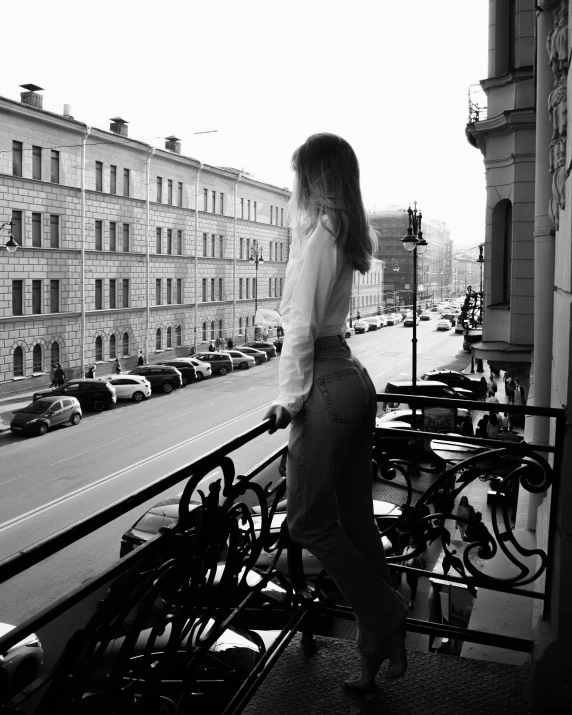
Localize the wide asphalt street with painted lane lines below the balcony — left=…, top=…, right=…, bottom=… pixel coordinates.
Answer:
left=0, top=321, right=462, bottom=623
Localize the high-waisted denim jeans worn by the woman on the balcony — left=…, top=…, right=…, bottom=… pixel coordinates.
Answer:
left=286, top=336, right=407, bottom=652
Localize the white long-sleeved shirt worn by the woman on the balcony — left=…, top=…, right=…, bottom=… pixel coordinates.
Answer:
left=274, top=223, right=353, bottom=417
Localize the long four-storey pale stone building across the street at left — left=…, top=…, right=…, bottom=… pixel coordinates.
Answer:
left=0, top=85, right=290, bottom=393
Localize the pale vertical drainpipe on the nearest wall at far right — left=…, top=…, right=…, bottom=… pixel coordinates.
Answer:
left=526, top=5, right=554, bottom=531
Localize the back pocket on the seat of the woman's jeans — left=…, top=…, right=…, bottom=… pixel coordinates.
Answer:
left=316, top=368, right=367, bottom=424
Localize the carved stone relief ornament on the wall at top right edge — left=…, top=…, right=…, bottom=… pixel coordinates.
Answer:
left=541, top=0, right=571, bottom=230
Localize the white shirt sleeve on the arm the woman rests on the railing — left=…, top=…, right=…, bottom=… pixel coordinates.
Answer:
left=274, top=224, right=338, bottom=417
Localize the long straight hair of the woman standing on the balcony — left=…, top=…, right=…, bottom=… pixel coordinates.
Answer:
left=288, top=134, right=377, bottom=273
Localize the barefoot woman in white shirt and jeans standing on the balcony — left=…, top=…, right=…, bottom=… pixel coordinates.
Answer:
left=265, top=134, right=407, bottom=690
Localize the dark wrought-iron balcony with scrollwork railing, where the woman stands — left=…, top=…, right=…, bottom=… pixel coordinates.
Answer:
left=0, top=394, right=565, bottom=715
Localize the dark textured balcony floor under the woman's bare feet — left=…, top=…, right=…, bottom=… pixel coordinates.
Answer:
left=243, top=634, right=535, bottom=715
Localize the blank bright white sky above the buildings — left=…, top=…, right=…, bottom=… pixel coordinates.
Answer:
left=0, top=0, right=489, bottom=246
